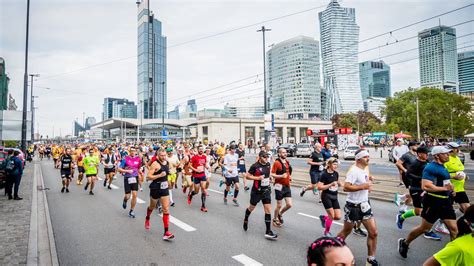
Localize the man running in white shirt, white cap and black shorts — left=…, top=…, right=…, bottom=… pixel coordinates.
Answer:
left=338, top=150, right=379, bottom=265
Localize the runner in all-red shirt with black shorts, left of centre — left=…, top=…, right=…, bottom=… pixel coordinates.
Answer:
left=188, top=146, right=207, bottom=212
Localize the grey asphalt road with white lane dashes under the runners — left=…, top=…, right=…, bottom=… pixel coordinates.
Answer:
left=41, top=161, right=458, bottom=265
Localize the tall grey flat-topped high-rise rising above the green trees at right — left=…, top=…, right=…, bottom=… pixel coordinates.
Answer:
left=418, top=26, right=458, bottom=93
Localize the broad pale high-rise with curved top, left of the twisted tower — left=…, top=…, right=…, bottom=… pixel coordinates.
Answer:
left=267, top=36, right=321, bottom=119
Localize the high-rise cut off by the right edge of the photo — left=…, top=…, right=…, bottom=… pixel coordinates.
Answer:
left=458, top=51, right=474, bottom=96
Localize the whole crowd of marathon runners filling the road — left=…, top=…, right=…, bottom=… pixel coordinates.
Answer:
left=26, top=139, right=474, bottom=265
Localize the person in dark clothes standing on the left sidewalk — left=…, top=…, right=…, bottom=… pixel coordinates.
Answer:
left=5, top=150, right=23, bottom=200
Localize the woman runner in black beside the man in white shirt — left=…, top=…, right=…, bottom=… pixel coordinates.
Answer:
left=318, top=158, right=342, bottom=236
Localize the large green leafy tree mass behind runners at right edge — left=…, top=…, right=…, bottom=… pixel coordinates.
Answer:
left=382, top=88, right=474, bottom=138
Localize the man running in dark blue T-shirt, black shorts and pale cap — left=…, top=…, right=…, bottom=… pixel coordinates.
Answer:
left=398, top=146, right=457, bottom=258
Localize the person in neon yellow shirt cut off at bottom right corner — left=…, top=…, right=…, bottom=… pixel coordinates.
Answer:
left=423, top=205, right=474, bottom=266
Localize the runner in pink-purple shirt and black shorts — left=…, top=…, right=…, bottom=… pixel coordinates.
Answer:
left=118, top=147, right=141, bottom=218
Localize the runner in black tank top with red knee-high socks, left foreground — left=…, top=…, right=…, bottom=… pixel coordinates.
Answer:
left=145, top=150, right=174, bottom=240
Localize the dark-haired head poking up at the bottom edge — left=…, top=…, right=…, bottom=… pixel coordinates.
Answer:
left=306, top=237, right=355, bottom=266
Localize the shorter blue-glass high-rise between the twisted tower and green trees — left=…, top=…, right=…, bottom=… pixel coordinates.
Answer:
left=359, top=61, right=391, bottom=100
